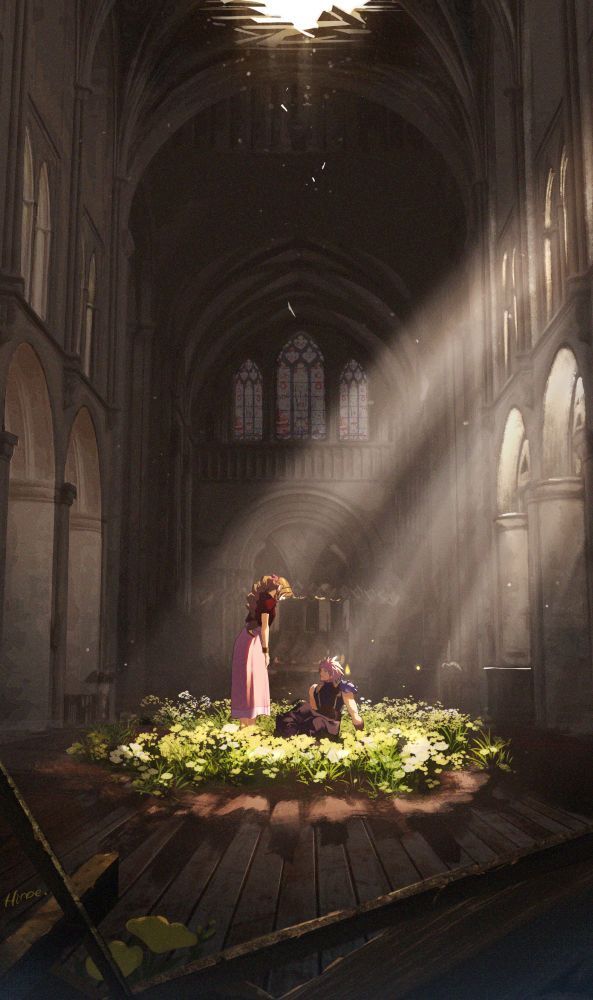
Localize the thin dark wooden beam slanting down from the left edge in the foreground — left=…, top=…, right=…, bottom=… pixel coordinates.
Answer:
left=0, top=760, right=132, bottom=998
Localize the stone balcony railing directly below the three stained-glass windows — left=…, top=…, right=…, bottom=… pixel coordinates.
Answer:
left=196, top=442, right=395, bottom=482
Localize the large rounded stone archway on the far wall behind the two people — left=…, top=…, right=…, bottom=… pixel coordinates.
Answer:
left=202, top=488, right=384, bottom=697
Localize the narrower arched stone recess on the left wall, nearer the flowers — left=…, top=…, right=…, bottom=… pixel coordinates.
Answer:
left=64, top=408, right=103, bottom=723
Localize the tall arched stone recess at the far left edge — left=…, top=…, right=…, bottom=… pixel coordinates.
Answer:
left=0, top=344, right=55, bottom=728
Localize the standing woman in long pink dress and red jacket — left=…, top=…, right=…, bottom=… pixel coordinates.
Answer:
left=231, top=575, right=293, bottom=726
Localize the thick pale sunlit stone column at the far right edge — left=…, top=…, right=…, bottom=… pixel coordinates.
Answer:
left=528, top=477, right=593, bottom=731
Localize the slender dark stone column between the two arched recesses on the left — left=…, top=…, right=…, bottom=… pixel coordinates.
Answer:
left=51, top=483, right=76, bottom=726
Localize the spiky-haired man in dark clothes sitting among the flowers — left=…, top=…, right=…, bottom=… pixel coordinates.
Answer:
left=275, top=657, right=364, bottom=739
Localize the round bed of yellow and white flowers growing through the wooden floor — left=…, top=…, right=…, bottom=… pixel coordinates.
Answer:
left=68, top=691, right=511, bottom=796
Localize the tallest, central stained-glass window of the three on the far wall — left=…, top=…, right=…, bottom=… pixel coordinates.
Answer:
left=276, top=333, right=325, bottom=441
